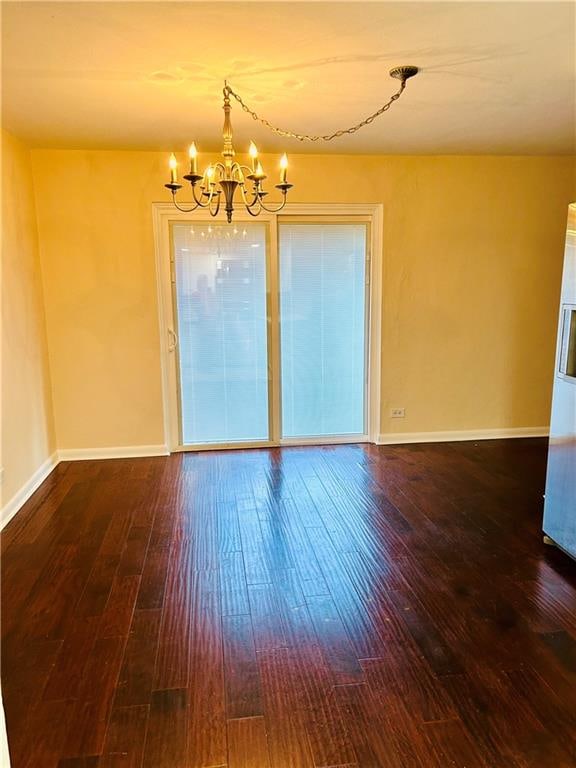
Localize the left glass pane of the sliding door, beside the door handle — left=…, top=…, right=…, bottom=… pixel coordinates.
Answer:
left=172, top=223, right=268, bottom=445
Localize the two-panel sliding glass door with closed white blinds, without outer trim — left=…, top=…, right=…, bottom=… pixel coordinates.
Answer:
left=172, top=217, right=368, bottom=447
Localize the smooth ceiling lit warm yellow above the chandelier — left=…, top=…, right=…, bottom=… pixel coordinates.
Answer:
left=2, top=2, right=576, bottom=154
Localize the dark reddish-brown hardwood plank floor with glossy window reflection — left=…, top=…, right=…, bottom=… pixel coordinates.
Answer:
left=2, top=440, right=576, bottom=768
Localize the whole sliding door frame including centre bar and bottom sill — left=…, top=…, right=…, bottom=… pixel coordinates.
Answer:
left=152, top=202, right=383, bottom=453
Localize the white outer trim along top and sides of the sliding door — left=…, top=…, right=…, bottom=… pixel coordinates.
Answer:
left=152, top=202, right=384, bottom=451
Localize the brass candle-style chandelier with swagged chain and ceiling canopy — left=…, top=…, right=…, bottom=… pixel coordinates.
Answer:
left=164, top=66, right=418, bottom=223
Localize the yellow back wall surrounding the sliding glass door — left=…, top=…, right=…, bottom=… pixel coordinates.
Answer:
left=32, top=150, right=576, bottom=448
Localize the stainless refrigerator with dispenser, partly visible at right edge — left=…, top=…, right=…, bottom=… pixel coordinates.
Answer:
left=543, top=203, right=576, bottom=558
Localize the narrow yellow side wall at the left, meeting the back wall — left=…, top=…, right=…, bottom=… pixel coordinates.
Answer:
left=0, top=133, right=56, bottom=506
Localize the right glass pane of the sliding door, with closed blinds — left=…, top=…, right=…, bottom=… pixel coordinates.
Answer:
left=280, top=223, right=366, bottom=437
